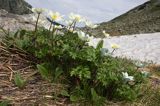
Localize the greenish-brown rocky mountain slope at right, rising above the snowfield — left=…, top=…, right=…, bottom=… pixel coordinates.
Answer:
left=84, top=0, right=160, bottom=36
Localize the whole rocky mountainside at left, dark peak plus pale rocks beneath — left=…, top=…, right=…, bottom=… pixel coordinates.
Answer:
left=0, top=0, right=34, bottom=37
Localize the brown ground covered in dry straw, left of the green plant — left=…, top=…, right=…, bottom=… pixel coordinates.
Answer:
left=0, top=42, right=67, bottom=106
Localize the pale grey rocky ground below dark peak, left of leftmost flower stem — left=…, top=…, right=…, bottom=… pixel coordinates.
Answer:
left=0, top=10, right=34, bottom=32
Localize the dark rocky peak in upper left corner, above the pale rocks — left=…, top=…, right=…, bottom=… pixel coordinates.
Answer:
left=0, top=0, right=32, bottom=14
